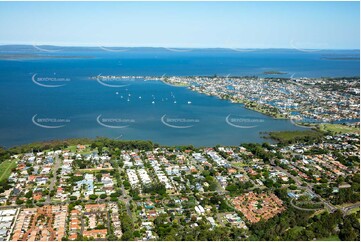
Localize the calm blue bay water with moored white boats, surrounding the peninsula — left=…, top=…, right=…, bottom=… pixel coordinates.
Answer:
left=0, top=47, right=360, bottom=147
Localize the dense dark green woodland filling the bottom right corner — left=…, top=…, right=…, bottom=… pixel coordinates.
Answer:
left=250, top=189, right=360, bottom=240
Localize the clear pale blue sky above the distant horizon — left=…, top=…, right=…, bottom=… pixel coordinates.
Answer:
left=0, top=1, right=360, bottom=49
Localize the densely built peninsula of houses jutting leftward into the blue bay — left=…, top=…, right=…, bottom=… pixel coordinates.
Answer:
left=92, top=75, right=360, bottom=124
